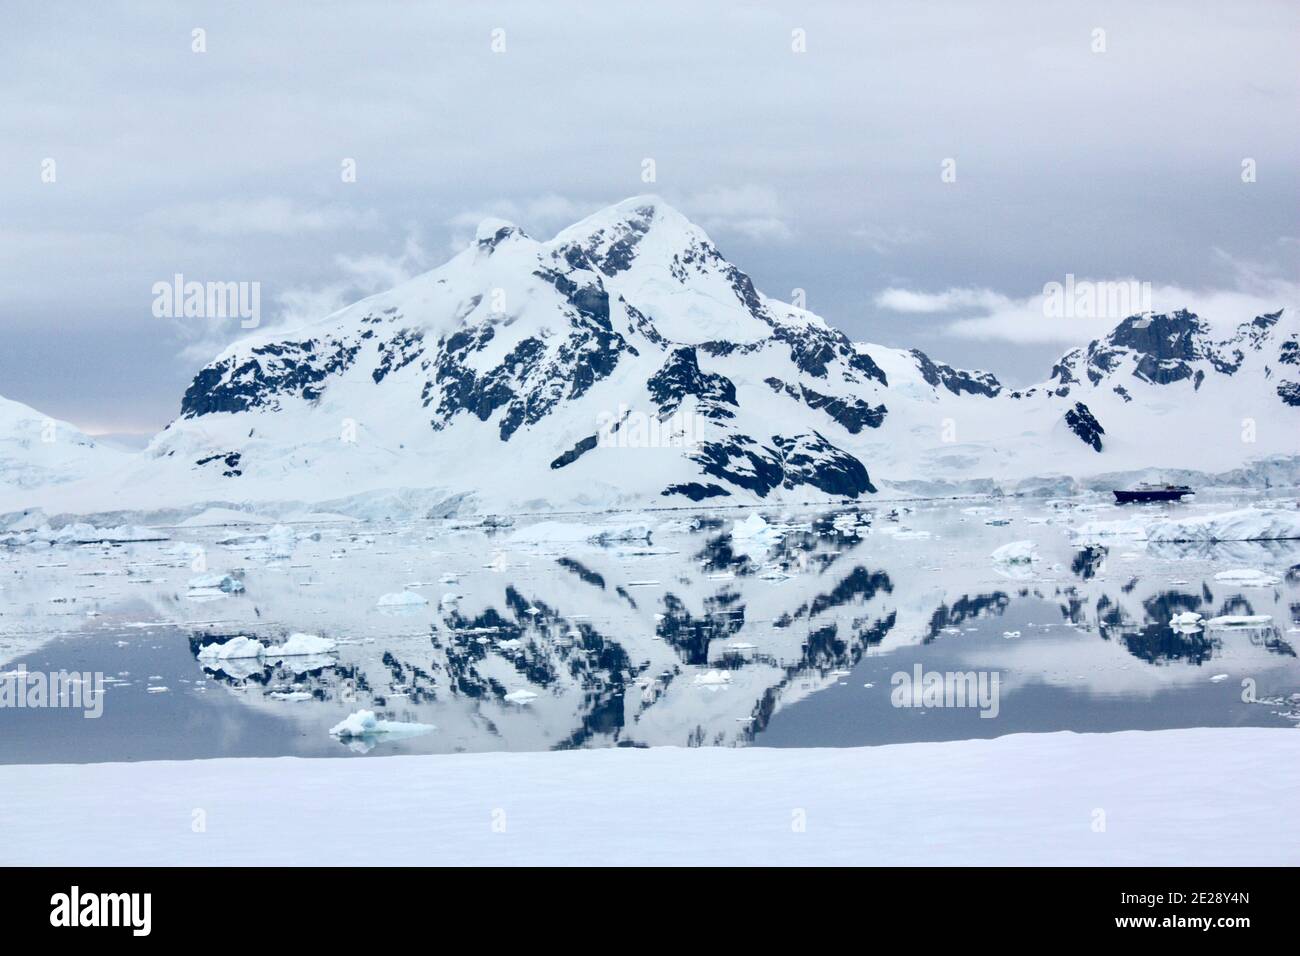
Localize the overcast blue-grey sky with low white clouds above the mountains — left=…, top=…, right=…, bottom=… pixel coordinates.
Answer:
left=0, top=0, right=1300, bottom=432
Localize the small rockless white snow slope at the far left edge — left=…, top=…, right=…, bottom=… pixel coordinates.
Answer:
left=0, top=397, right=129, bottom=496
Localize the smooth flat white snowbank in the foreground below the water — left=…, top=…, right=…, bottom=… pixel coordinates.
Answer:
left=0, top=728, right=1300, bottom=865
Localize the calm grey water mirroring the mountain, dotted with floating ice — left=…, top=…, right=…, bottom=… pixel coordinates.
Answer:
left=0, top=502, right=1300, bottom=762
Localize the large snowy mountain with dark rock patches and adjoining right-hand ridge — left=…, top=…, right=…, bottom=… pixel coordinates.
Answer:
left=2, top=196, right=1300, bottom=520
